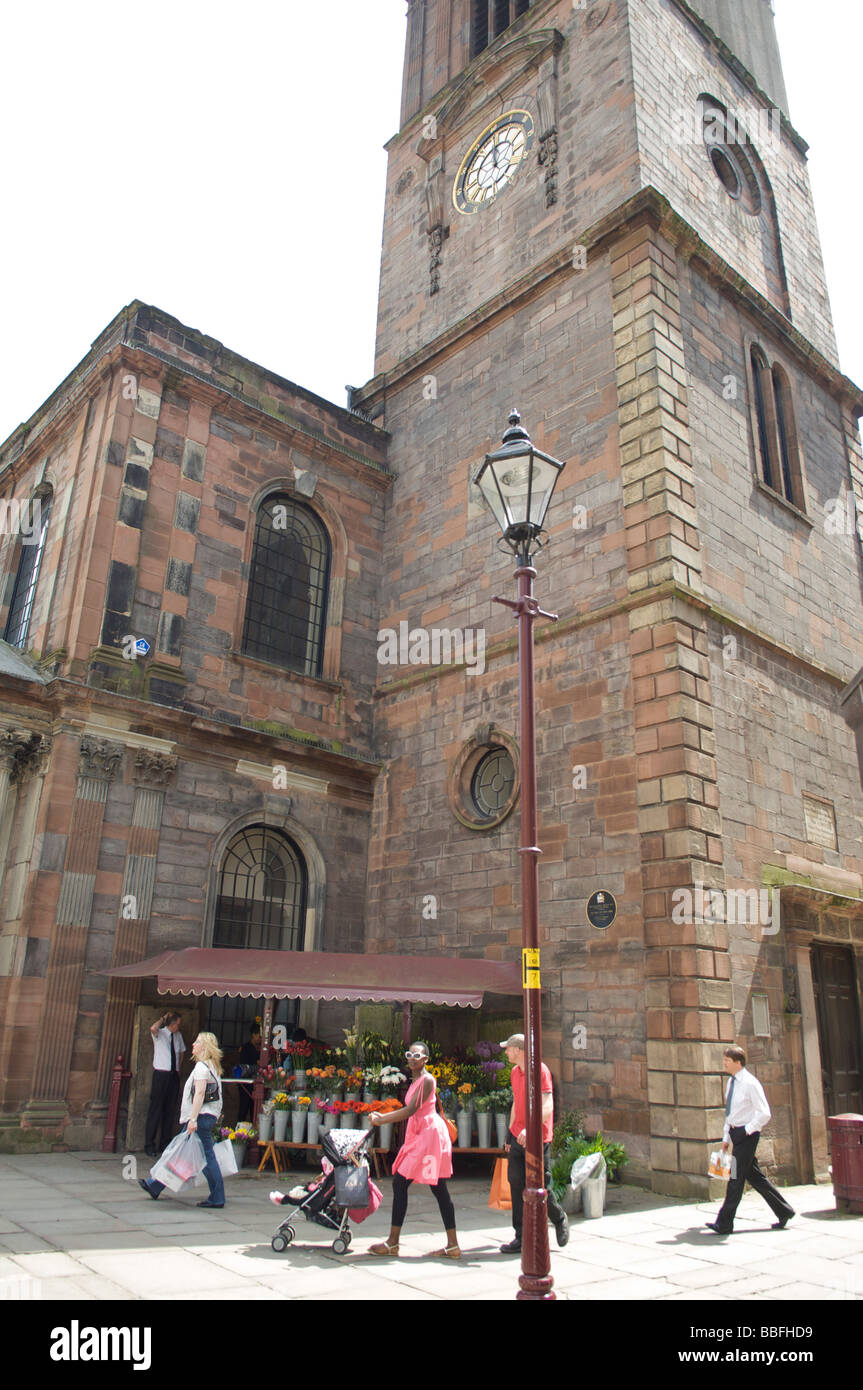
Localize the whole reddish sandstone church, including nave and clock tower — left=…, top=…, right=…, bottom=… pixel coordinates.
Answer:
left=0, top=0, right=863, bottom=1194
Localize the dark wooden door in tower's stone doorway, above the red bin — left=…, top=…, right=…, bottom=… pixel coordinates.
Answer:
left=812, top=942, right=863, bottom=1115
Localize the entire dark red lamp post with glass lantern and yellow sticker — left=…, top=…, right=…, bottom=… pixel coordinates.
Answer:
left=475, top=410, right=564, bottom=1301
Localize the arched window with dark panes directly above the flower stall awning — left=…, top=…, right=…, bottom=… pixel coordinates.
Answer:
left=207, top=826, right=309, bottom=1049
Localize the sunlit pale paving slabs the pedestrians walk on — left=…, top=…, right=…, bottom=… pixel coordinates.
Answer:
left=0, top=1154, right=863, bottom=1302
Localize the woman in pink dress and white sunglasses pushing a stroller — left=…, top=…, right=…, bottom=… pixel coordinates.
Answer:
left=368, top=1043, right=461, bottom=1259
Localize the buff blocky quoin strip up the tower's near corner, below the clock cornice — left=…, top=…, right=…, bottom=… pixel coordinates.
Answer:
left=611, top=224, right=734, bottom=1193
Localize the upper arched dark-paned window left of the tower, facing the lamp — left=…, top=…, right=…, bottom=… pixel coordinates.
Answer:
left=242, top=493, right=329, bottom=676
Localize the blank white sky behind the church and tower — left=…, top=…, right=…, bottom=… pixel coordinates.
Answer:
left=0, top=0, right=863, bottom=441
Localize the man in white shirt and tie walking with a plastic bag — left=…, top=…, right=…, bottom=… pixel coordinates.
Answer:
left=707, top=1047, right=794, bottom=1236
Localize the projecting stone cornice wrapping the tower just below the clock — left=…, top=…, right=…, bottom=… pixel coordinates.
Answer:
left=357, top=188, right=863, bottom=416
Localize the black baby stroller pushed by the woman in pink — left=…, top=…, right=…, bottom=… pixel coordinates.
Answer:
left=270, top=1129, right=381, bottom=1255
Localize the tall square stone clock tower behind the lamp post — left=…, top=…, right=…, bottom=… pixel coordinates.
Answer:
left=354, top=0, right=863, bottom=1193
